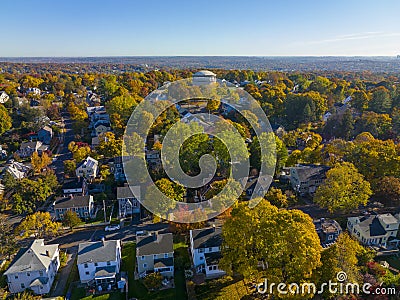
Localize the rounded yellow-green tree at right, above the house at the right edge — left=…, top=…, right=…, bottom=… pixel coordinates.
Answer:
left=314, top=162, right=372, bottom=213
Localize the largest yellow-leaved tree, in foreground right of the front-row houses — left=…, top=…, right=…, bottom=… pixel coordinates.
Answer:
left=220, top=200, right=322, bottom=299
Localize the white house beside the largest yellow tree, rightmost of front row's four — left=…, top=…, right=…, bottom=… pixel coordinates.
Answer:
left=190, top=227, right=225, bottom=278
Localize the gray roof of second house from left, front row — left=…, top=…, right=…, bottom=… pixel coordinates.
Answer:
left=77, top=240, right=120, bottom=265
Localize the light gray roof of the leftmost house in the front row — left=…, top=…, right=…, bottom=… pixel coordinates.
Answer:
left=4, top=239, right=58, bottom=275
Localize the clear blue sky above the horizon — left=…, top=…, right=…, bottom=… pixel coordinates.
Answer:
left=0, top=0, right=400, bottom=57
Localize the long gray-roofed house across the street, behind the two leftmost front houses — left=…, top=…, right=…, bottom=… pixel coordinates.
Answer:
left=54, top=195, right=94, bottom=220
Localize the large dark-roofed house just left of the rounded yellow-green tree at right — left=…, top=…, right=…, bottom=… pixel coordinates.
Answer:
left=289, top=164, right=330, bottom=196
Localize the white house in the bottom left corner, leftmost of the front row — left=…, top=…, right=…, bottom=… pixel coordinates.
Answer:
left=4, top=239, right=60, bottom=295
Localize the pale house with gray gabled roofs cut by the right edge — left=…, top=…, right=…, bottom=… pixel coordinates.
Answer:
left=347, top=213, right=399, bottom=247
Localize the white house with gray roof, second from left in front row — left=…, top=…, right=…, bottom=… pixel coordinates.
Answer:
left=77, top=239, right=121, bottom=290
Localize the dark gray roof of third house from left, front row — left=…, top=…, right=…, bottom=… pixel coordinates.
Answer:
left=136, top=233, right=174, bottom=256
